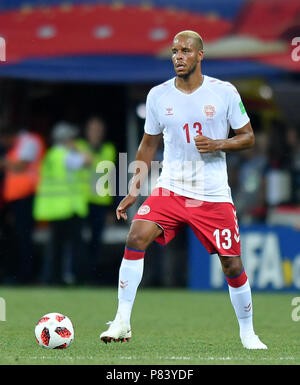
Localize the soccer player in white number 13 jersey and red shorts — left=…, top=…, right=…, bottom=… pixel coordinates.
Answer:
left=100, top=31, right=267, bottom=349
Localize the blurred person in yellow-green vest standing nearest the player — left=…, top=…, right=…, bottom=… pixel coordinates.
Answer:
left=76, top=116, right=116, bottom=284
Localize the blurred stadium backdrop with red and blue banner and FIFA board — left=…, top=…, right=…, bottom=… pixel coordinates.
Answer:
left=0, top=0, right=300, bottom=291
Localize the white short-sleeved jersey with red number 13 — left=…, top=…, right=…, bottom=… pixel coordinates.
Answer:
left=145, top=75, right=249, bottom=202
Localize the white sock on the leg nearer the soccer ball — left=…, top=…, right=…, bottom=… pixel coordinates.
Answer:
left=116, top=258, right=144, bottom=326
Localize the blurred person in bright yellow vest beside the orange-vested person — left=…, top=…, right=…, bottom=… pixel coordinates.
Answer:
left=33, top=122, right=92, bottom=285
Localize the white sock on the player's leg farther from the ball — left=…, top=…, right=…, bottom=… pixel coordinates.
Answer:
left=228, top=279, right=254, bottom=337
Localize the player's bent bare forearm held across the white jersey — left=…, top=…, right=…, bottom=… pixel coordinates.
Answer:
left=194, top=122, right=255, bottom=153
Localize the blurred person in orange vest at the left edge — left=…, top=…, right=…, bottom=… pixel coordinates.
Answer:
left=0, top=126, right=45, bottom=283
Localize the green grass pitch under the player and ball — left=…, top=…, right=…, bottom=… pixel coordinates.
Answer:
left=0, top=286, right=300, bottom=365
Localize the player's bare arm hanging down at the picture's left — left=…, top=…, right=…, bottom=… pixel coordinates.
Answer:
left=116, top=133, right=162, bottom=220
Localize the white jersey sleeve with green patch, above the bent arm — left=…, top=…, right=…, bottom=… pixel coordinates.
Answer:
left=228, top=86, right=250, bottom=130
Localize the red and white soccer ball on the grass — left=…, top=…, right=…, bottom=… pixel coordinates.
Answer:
left=35, top=313, right=74, bottom=349
